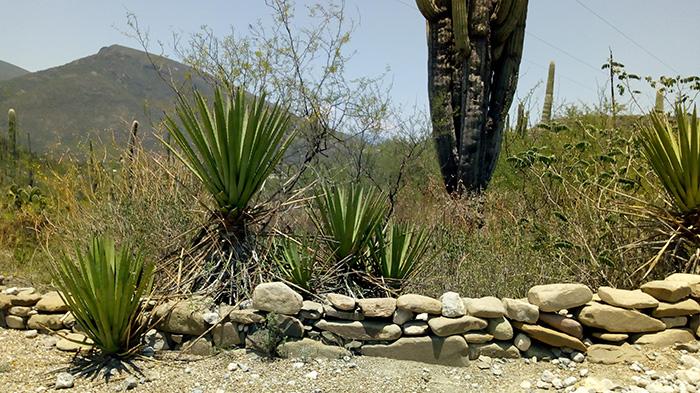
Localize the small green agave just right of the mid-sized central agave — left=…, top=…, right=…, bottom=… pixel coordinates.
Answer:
left=370, top=222, right=430, bottom=280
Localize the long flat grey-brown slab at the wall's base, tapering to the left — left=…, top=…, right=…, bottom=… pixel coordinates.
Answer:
left=360, top=336, right=469, bottom=367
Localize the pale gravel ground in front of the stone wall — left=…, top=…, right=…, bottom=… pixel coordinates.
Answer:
left=0, top=328, right=698, bottom=393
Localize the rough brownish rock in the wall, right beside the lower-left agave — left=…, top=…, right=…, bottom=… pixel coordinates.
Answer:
left=154, top=301, right=209, bottom=336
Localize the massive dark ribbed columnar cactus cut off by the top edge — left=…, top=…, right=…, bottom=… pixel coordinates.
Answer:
left=416, top=0, right=528, bottom=194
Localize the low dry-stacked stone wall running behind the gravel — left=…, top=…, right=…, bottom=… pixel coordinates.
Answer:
left=0, top=274, right=700, bottom=366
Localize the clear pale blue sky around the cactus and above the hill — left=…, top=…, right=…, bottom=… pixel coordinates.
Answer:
left=0, top=0, right=700, bottom=118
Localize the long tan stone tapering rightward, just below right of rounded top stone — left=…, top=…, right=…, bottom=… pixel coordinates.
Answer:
left=578, top=303, right=666, bottom=333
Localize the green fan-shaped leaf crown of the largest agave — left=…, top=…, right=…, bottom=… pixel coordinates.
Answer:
left=161, top=88, right=292, bottom=224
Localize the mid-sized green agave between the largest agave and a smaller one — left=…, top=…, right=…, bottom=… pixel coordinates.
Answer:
left=312, top=184, right=387, bottom=269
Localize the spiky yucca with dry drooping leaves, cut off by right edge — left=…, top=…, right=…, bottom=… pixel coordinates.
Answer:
left=638, top=103, right=700, bottom=277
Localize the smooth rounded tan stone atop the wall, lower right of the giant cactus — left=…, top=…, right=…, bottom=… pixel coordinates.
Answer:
left=527, top=284, right=593, bottom=312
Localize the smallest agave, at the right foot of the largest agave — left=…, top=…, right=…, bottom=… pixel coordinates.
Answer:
left=273, top=238, right=315, bottom=290
